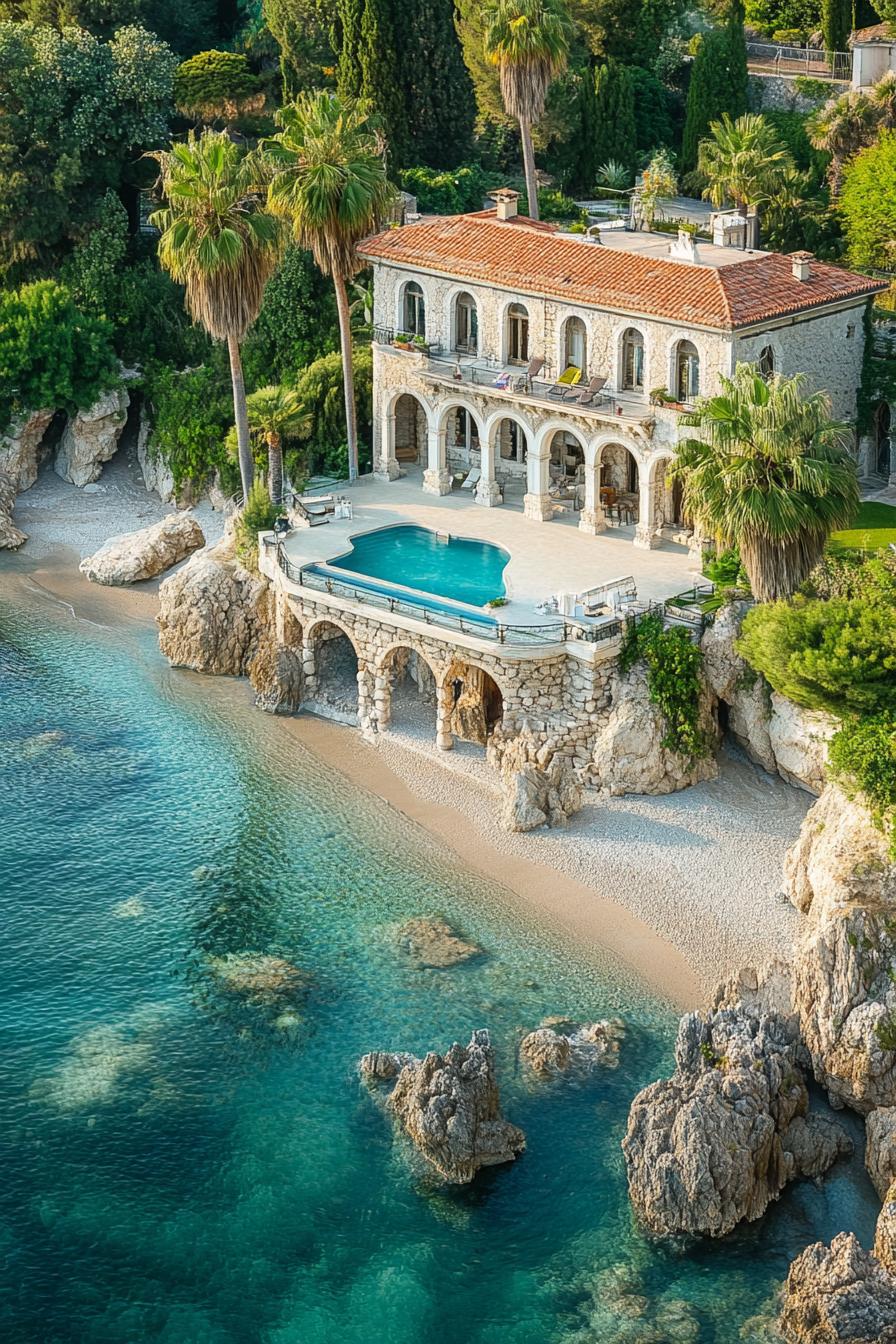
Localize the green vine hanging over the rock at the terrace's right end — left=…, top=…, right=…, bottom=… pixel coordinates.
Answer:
left=619, top=616, right=709, bottom=761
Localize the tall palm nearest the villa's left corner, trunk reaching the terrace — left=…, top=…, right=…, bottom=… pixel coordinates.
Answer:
left=266, top=93, right=395, bottom=481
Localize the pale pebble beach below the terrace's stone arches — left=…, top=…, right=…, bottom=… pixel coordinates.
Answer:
left=377, top=696, right=813, bottom=989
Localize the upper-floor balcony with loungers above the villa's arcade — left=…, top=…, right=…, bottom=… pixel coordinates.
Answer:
left=373, top=327, right=657, bottom=434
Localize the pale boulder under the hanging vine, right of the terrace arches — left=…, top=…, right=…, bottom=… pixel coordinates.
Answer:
left=588, top=665, right=719, bottom=794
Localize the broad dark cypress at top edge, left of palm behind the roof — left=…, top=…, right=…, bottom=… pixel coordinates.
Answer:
left=405, top=0, right=476, bottom=168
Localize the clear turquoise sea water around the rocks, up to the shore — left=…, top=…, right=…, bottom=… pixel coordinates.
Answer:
left=0, top=583, right=876, bottom=1344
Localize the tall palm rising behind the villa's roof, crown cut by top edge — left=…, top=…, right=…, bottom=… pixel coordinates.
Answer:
left=484, top=0, right=571, bottom=219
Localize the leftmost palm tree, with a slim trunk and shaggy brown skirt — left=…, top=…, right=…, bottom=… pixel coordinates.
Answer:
left=149, top=130, right=282, bottom=499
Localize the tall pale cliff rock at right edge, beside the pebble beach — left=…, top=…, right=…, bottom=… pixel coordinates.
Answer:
left=785, top=786, right=896, bottom=1113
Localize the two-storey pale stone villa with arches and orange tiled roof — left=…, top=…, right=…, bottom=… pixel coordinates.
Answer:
left=360, top=192, right=885, bottom=547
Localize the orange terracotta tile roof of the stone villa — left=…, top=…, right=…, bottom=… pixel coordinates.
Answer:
left=359, top=211, right=887, bottom=331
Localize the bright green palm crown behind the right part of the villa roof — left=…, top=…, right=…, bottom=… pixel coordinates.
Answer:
left=697, top=112, right=794, bottom=240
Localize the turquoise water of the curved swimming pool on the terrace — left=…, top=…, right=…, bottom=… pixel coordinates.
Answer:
left=329, top=523, right=510, bottom=606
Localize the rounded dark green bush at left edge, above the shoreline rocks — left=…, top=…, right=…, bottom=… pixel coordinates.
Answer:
left=0, top=280, right=121, bottom=430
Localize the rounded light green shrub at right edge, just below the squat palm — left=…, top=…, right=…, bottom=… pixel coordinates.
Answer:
left=737, top=595, right=896, bottom=715
